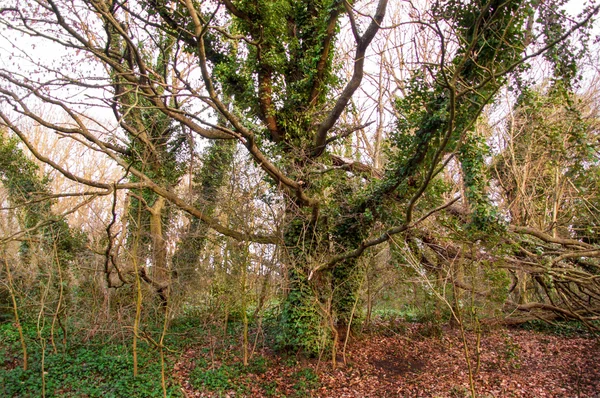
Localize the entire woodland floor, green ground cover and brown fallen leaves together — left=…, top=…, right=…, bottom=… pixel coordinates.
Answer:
left=0, top=318, right=600, bottom=398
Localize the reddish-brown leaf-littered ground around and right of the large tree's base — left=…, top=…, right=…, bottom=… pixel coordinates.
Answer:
left=174, top=323, right=600, bottom=398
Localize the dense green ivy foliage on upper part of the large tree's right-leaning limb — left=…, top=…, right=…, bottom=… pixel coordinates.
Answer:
left=368, top=0, right=529, bottom=224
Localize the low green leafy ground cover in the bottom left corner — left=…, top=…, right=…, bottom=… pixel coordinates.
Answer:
left=0, top=325, right=181, bottom=398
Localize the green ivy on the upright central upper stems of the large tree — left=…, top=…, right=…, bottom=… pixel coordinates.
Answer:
left=188, top=0, right=343, bottom=147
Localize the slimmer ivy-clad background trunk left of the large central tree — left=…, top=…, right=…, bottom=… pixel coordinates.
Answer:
left=103, top=13, right=188, bottom=306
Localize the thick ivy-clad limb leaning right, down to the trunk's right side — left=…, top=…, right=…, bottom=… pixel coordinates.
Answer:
left=292, top=1, right=525, bottom=352
